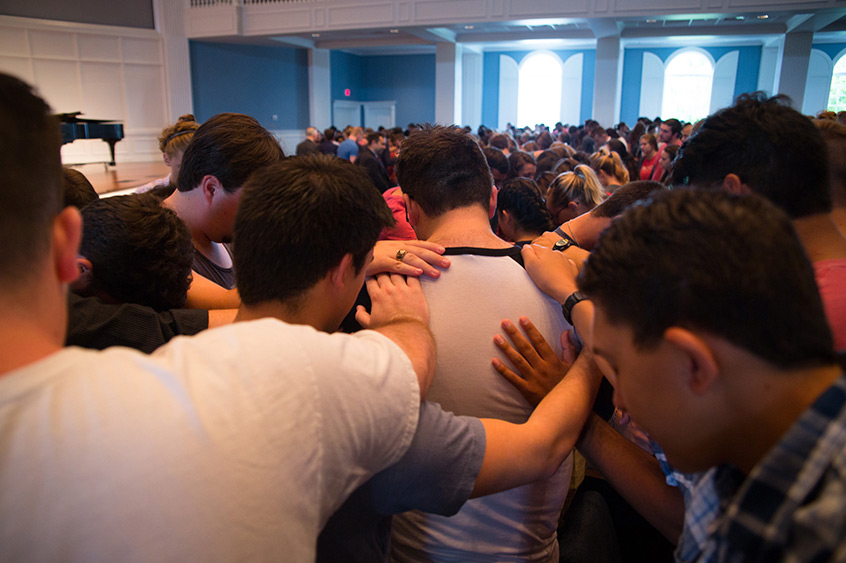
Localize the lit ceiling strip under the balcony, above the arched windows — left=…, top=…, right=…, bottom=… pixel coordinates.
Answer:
left=262, top=9, right=846, bottom=55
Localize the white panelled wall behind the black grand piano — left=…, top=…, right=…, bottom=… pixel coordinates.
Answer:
left=0, top=17, right=174, bottom=163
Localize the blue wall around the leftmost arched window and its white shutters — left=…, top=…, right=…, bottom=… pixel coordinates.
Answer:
left=482, top=50, right=596, bottom=128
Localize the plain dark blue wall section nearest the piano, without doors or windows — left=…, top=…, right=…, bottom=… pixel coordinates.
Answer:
left=190, top=41, right=309, bottom=129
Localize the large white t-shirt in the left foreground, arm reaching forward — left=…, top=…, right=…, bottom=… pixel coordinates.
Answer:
left=0, top=320, right=420, bottom=562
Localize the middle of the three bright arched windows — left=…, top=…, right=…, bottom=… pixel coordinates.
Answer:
left=661, top=50, right=714, bottom=123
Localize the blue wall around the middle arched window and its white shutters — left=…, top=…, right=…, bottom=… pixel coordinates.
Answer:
left=620, top=46, right=761, bottom=123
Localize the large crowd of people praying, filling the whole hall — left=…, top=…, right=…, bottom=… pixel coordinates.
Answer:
left=0, top=68, right=846, bottom=562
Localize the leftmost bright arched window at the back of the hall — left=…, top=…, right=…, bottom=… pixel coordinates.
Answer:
left=517, top=51, right=562, bottom=127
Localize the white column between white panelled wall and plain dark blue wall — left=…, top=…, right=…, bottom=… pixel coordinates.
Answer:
left=153, top=0, right=194, bottom=123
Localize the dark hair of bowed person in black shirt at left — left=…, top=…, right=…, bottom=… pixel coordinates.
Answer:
left=79, top=194, right=194, bottom=311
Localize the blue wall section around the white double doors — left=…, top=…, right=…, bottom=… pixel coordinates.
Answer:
left=330, top=51, right=435, bottom=127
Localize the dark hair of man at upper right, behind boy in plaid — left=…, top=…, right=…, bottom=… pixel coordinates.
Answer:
left=672, top=92, right=831, bottom=218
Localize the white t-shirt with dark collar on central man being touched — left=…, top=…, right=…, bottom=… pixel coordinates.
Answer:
left=391, top=249, right=572, bottom=562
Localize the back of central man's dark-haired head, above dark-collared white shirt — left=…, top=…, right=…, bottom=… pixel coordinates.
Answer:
left=397, top=126, right=493, bottom=217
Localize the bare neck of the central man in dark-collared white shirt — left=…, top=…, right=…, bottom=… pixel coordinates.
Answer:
left=415, top=205, right=512, bottom=248
